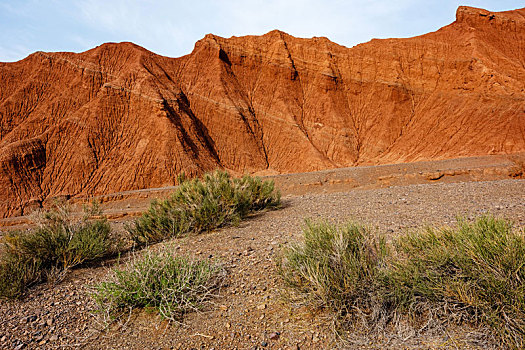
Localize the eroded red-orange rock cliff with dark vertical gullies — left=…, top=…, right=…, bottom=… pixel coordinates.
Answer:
left=0, top=7, right=525, bottom=217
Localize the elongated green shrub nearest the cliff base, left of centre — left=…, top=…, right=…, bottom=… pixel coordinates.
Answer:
left=128, top=171, right=280, bottom=245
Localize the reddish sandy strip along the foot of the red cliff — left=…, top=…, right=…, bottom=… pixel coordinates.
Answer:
left=0, top=153, right=525, bottom=229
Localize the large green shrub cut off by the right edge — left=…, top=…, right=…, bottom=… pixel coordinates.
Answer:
left=382, top=216, right=525, bottom=348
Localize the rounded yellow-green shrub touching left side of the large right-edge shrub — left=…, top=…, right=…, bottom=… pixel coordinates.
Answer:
left=277, top=220, right=384, bottom=315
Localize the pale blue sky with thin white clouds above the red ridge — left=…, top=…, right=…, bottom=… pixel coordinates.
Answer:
left=0, top=0, right=525, bottom=62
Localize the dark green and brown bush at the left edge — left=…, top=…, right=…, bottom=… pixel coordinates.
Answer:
left=0, top=204, right=115, bottom=298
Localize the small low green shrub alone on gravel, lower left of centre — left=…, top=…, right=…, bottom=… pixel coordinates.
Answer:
left=93, top=248, right=225, bottom=321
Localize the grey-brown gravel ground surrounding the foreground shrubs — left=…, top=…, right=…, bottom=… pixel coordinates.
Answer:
left=0, top=180, right=525, bottom=349
